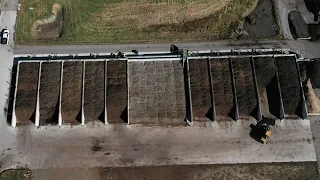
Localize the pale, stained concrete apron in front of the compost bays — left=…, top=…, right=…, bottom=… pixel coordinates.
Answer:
left=3, top=120, right=316, bottom=169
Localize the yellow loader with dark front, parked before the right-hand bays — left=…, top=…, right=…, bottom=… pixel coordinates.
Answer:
left=250, top=123, right=272, bottom=144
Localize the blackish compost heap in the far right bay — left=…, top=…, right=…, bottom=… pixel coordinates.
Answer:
left=275, top=57, right=301, bottom=115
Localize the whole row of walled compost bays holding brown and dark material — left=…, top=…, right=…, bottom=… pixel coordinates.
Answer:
left=10, top=49, right=307, bottom=127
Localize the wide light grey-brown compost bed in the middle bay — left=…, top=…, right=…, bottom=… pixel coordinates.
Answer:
left=128, top=61, right=186, bottom=125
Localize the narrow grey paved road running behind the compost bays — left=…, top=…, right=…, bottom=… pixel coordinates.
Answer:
left=14, top=40, right=320, bottom=58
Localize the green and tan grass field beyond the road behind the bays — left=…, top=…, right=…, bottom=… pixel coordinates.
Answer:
left=16, top=0, right=257, bottom=44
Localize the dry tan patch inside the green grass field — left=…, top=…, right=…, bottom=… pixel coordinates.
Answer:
left=97, top=0, right=232, bottom=29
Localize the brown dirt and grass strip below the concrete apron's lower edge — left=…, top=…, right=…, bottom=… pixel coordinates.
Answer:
left=28, top=162, right=319, bottom=180
